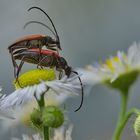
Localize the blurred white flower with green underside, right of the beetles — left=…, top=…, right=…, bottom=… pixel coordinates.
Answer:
left=78, top=43, right=140, bottom=90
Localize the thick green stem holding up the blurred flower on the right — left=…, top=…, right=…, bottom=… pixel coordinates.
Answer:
left=112, top=91, right=128, bottom=140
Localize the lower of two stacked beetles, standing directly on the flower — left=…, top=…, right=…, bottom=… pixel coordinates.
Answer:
left=13, top=48, right=84, bottom=112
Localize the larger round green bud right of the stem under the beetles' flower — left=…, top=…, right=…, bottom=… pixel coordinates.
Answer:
left=42, top=106, right=64, bottom=128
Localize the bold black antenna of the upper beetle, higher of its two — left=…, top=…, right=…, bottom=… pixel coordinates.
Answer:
left=28, top=6, right=60, bottom=42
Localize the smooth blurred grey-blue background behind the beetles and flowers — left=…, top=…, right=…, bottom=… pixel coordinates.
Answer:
left=0, top=0, right=140, bottom=140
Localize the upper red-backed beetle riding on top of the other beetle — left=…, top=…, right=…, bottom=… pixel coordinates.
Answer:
left=8, top=7, right=62, bottom=75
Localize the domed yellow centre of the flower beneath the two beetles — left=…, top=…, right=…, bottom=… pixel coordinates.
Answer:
left=14, top=69, right=56, bottom=89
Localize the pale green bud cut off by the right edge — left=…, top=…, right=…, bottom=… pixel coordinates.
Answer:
left=134, top=115, right=140, bottom=138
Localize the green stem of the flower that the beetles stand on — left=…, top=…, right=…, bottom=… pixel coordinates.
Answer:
left=37, top=94, right=49, bottom=140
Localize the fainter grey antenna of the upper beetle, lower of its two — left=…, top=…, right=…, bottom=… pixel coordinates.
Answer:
left=23, top=20, right=57, bottom=38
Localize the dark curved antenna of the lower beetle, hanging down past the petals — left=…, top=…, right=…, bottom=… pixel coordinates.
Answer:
left=72, top=71, right=84, bottom=112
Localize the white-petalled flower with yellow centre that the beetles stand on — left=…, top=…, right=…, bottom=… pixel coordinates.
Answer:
left=0, top=70, right=81, bottom=110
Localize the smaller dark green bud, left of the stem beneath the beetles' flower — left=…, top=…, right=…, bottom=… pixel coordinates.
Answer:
left=30, top=109, right=42, bottom=130
